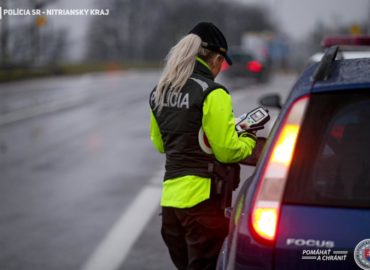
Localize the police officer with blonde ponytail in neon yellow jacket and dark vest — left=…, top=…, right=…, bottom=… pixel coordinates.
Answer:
left=150, top=22, right=256, bottom=270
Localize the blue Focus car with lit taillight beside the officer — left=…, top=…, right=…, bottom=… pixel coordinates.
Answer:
left=217, top=46, right=370, bottom=270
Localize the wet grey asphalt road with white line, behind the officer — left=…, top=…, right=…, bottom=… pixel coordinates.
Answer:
left=0, top=71, right=295, bottom=270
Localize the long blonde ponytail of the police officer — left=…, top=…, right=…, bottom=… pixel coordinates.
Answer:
left=154, top=34, right=217, bottom=112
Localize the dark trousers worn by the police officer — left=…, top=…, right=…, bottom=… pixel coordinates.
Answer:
left=161, top=199, right=228, bottom=270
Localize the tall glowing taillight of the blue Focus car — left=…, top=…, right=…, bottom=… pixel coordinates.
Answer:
left=250, top=96, right=309, bottom=243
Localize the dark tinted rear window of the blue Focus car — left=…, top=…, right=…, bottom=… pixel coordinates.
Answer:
left=284, top=90, right=370, bottom=208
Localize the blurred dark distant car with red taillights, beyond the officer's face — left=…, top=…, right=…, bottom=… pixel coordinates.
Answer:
left=221, top=49, right=270, bottom=83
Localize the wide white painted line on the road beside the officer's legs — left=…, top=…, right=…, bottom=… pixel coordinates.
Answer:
left=82, top=176, right=161, bottom=270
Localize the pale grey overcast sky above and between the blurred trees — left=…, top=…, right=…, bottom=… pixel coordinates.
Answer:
left=44, top=0, right=370, bottom=58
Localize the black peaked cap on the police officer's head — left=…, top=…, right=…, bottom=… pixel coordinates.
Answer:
left=189, top=22, right=233, bottom=65
